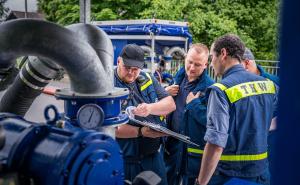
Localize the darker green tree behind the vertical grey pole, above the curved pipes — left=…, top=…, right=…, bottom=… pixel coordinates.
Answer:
left=38, top=0, right=148, bottom=25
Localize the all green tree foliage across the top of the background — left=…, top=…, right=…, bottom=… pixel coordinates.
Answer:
left=38, top=0, right=280, bottom=60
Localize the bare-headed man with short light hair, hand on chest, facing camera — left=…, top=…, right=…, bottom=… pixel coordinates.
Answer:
left=165, top=43, right=213, bottom=185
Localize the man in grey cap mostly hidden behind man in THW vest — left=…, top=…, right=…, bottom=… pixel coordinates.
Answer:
left=242, top=48, right=279, bottom=182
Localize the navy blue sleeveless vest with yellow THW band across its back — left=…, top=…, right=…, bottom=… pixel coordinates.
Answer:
left=209, top=65, right=277, bottom=177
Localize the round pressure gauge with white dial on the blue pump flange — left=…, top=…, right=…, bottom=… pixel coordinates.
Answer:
left=77, top=104, right=104, bottom=130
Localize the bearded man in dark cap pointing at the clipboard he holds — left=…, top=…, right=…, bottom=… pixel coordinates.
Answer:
left=114, top=44, right=176, bottom=185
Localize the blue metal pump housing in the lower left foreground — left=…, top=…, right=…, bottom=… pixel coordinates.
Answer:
left=0, top=113, right=123, bottom=185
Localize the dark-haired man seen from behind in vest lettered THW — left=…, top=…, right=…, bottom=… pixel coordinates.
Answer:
left=195, top=34, right=277, bottom=185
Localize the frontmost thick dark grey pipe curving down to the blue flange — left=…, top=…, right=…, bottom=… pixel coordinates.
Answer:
left=0, top=19, right=111, bottom=94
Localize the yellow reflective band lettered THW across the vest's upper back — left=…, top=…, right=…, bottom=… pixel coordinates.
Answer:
left=225, top=81, right=275, bottom=103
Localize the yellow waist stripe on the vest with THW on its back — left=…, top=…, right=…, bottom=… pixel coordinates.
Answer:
left=220, top=152, right=268, bottom=161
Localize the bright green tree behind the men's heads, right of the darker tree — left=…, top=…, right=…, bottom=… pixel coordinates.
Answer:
left=141, top=0, right=280, bottom=60
